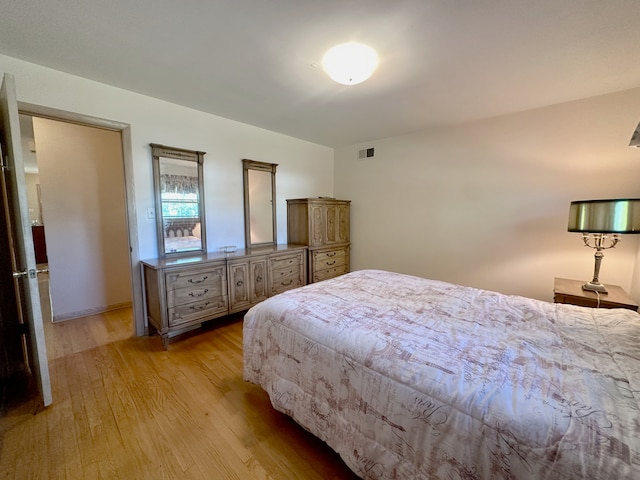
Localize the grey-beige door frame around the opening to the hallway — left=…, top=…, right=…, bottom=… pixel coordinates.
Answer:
left=18, top=102, right=146, bottom=336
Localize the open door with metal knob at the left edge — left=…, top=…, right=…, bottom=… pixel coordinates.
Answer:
left=0, top=73, right=52, bottom=407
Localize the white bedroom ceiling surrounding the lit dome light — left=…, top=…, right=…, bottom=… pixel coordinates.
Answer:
left=0, top=0, right=640, bottom=147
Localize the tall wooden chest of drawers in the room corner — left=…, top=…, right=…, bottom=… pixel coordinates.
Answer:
left=287, top=198, right=351, bottom=283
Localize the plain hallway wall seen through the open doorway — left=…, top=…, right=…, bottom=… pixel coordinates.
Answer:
left=33, top=117, right=132, bottom=321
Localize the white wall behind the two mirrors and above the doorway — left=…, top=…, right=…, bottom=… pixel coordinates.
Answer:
left=0, top=51, right=333, bottom=327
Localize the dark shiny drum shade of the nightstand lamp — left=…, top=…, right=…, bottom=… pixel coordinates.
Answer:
left=568, top=198, right=640, bottom=233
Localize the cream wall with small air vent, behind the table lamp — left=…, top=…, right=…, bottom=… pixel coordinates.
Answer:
left=335, top=89, right=640, bottom=300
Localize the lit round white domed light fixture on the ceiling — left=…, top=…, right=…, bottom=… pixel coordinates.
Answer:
left=322, top=42, right=378, bottom=85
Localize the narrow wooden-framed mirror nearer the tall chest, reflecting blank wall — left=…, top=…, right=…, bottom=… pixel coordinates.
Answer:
left=242, top=159, right=278, bottom=249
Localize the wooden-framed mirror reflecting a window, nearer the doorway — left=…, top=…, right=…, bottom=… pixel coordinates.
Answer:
left=151, top=143, right=207, bottom=257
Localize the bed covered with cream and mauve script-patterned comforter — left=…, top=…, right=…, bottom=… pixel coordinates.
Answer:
left=243, top=270, right=640, bottom=480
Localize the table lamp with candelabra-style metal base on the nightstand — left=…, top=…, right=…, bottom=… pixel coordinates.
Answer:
left=568, top=198, right=640, bottom=293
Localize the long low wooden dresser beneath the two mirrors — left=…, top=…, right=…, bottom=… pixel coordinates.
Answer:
left=141, top=245, right=307, bottom=349
